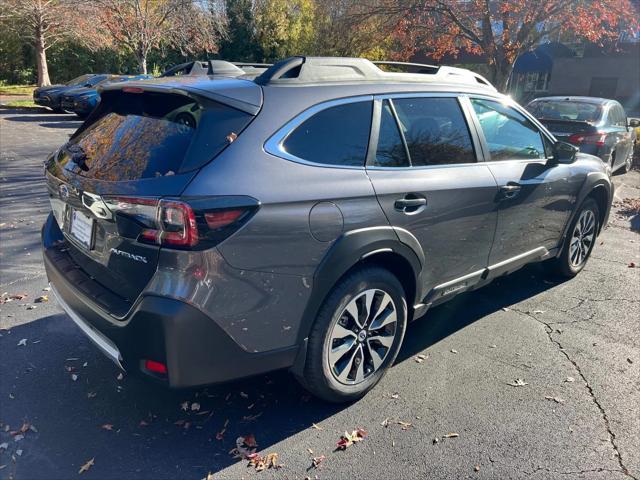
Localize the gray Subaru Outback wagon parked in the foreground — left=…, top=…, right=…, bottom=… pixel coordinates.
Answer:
left=42, top=57, right=613, bottom=401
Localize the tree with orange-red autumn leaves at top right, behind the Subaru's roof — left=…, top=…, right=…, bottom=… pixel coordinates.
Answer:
left=368, top=0, right=640, bottom=90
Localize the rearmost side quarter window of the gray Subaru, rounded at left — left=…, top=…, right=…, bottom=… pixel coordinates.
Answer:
left=283, top=101, right=373, bottom=166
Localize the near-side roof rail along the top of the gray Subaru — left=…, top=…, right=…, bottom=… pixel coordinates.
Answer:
left=254, top=56, right=496, bottom=91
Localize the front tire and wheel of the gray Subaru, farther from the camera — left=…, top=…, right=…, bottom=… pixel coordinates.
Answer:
left=546, top=197, right=600, bottom=278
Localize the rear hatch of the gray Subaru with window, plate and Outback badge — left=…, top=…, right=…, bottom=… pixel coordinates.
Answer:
left=45, top=82, right=261, bottom=313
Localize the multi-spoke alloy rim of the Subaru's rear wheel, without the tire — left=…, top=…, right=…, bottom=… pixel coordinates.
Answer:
left=327, top=289, right=398, bottom=385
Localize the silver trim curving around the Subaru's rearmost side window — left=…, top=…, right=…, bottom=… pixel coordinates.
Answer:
left=263, top=95, right=374, bottom=170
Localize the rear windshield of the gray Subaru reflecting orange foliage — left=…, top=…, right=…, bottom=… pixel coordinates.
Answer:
left=66, top=91, right=252, bottom=181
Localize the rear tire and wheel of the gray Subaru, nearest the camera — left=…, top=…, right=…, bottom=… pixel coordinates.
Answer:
left=301, top=267, right=407, bottom=403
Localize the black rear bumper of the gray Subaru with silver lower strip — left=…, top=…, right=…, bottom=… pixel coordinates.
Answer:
left=43, top=216, right=298, bottom=388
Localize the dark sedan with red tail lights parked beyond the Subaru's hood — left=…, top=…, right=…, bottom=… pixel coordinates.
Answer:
left=526, top=97, right=640, bottom=173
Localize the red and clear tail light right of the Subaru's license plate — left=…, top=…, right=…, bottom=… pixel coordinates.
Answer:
left=104, top=196, right=259, bottom=249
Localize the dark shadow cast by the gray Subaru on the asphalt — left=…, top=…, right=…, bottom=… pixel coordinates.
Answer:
left=0, top=266, right=553, bottom=479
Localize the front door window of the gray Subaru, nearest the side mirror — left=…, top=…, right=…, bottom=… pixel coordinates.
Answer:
left=471, top=98, right=546, bottom=160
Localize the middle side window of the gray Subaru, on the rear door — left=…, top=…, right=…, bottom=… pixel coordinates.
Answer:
left=393, top=97, right=476, bottom=167
